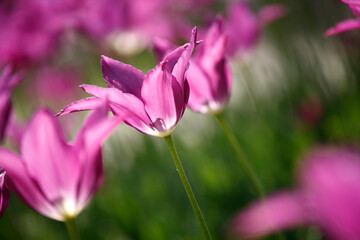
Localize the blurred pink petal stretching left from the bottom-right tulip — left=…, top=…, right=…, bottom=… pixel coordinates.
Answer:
left=230, top=193, right=307, bottom=238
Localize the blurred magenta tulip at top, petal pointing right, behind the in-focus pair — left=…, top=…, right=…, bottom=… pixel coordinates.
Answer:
left=226, top=1, right=287, bottom=56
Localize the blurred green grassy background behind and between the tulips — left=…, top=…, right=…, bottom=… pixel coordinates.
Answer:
left=0, top=0, right=360, bottom=240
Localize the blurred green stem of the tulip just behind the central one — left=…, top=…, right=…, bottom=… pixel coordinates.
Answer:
left=214, top=113, right=265, bottom=199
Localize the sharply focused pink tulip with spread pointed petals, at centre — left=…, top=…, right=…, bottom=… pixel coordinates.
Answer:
left=58, top=28, right=197, bottom=137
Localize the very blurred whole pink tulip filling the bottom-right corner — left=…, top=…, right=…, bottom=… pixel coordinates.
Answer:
left=231, top=148, right=360, bottom=240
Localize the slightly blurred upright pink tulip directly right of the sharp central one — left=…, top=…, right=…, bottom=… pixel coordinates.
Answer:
left=187, top=17, right=232, bottom=113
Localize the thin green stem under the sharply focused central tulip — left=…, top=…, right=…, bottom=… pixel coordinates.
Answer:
left=164, top=135, right=212, bottom=240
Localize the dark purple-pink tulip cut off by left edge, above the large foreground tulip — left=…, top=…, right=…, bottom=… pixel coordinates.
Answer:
left=0, top=67, right=22, bottom=142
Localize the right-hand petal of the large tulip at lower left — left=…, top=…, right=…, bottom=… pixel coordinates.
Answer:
left=74, top=101, right=122, bottom=208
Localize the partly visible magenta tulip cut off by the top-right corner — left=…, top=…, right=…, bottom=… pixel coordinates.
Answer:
left=325, top=0, right=360, bottom=36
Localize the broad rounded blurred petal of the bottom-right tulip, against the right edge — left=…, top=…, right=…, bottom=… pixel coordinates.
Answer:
left=301, top=148, right=360, bottom=239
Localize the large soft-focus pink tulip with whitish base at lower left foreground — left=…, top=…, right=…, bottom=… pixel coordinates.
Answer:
left=0, top=104, right=121, bottom=221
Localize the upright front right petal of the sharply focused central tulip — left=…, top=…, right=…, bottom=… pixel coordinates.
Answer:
left=141, top=62, right=186, bottom=135
